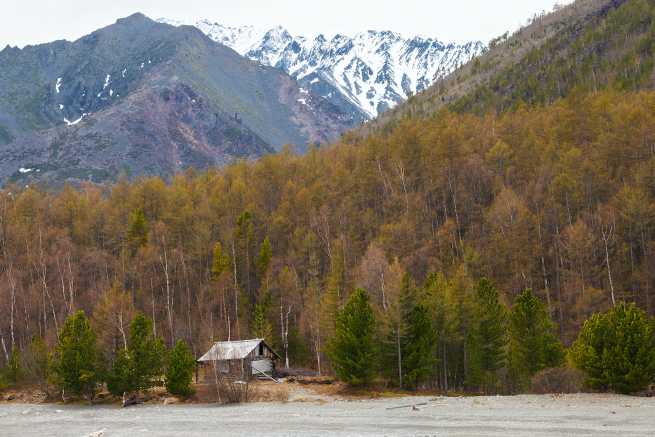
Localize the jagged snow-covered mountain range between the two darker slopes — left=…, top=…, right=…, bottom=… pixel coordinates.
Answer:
left=160, top=19, right=485, bottom=121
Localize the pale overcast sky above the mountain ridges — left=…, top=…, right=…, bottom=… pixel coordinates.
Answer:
left=0, top=0, right=571, bottom=48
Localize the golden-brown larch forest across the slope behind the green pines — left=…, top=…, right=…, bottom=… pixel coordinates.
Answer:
left=0, top=90, right=655, bottom=394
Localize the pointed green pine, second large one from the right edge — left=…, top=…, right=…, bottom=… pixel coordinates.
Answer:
left=509, top=289, right=564, bottom=390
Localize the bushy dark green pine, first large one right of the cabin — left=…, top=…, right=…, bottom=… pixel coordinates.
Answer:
left=328, top=289, right=377, bottom=386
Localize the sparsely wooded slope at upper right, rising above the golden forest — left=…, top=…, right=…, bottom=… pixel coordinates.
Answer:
left=372, top=0, right=655, bottom=130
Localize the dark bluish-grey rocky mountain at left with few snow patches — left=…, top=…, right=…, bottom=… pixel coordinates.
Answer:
left=0, top=14, right=358, bottom=184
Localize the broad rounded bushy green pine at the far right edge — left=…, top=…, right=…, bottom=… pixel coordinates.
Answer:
left=571, top=303, right=655, bottom=394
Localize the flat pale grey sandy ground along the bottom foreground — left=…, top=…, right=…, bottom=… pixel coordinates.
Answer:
left=0, top=395, right=655, bottom=437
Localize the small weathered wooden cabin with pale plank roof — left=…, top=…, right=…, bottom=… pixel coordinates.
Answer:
left=196, top=338, right=280, bottom=382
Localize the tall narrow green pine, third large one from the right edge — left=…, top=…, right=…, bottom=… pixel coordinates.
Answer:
left=467, top=278, right=507, bottom=393
